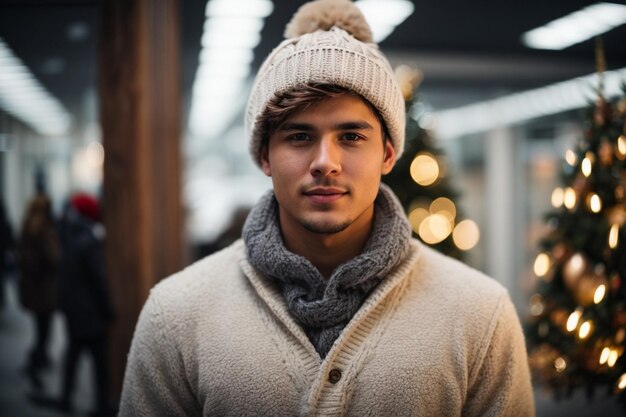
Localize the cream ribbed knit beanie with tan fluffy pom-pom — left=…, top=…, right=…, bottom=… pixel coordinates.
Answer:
left=245, top=0, right=405, bottom=166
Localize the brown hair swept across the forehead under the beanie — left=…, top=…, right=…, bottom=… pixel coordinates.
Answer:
left=253, top=83, right=390, bottom=149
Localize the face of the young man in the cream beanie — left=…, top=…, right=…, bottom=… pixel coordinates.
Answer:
left=261, top=94, right=395, bottom=236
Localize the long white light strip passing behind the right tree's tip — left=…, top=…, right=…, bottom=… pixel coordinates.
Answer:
left=435, top=68, right=626, bottom=139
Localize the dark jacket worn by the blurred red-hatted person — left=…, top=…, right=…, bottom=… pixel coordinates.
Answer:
left=59, top=210, right=113, bottom=339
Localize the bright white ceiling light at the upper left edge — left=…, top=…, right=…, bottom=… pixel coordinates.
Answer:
left=0, top=38, right=71, bottom=136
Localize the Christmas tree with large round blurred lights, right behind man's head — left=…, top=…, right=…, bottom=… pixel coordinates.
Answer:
left=383, top=65, right=479, bottom=258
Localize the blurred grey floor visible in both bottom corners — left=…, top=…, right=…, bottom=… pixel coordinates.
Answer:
left=0, top=272, right=626, bottom=417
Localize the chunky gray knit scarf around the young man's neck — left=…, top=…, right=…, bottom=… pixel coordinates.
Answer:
left=243, top=184, right=411, bottom=358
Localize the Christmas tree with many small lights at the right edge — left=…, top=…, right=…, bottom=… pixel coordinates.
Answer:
left=526, top=39, right=626, bottom=406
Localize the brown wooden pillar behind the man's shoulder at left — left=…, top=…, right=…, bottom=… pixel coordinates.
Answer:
left=99, top=0, right=184, bottom=395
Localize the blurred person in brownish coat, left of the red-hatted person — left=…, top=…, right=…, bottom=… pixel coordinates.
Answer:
left=17, top=190, right=61, bottom=391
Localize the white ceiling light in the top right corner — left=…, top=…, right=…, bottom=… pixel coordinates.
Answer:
left=522, top=3, right=626, bottom=50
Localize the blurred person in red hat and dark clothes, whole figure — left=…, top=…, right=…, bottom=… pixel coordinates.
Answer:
left=57, top=193, right=114, bottom=415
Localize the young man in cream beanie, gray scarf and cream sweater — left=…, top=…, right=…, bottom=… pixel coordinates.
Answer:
left=120, top=0, right=534, bottom=416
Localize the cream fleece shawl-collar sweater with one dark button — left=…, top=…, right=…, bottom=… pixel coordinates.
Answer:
left=119, top=241, right=534, bottom=417
